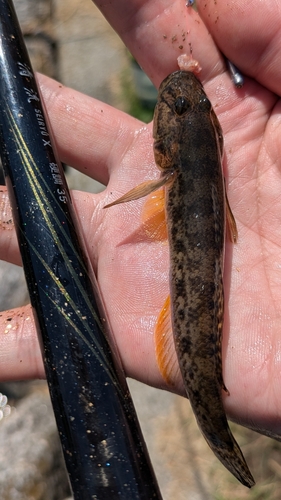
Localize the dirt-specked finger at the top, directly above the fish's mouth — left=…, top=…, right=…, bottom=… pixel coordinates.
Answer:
left=94, top=0, right=224, bottom=87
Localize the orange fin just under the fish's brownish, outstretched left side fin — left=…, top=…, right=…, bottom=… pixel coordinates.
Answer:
left=142, top=187, right=167, bottom=241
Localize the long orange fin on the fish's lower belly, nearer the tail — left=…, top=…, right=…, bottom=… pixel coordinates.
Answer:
left=154, top=295, right=179, bottom=386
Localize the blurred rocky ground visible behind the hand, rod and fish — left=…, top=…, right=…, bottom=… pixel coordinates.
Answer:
left=0, top=0, right=281, bottom=500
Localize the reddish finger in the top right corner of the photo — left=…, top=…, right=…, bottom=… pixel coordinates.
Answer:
left=197, top=0, right=281, bottom=95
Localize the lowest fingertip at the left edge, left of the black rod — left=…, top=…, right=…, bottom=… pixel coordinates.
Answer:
left=0, top=305, right=45, bottom=381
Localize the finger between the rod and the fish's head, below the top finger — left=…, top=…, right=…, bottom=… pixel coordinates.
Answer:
left=37, top=75, right=143, bottom=184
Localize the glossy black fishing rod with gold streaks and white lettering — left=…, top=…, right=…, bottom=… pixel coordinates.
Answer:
left=0, top=0, right=161, bottom=500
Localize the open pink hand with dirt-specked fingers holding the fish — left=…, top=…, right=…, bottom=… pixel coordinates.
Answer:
left=0, top=0, right=281, bottom=433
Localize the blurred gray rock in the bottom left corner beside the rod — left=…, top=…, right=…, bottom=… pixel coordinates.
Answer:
left=0, top=390, right=70, bottom=500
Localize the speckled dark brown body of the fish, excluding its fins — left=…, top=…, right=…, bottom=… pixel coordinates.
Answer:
left=154, top=71, right=254, bottom=487
